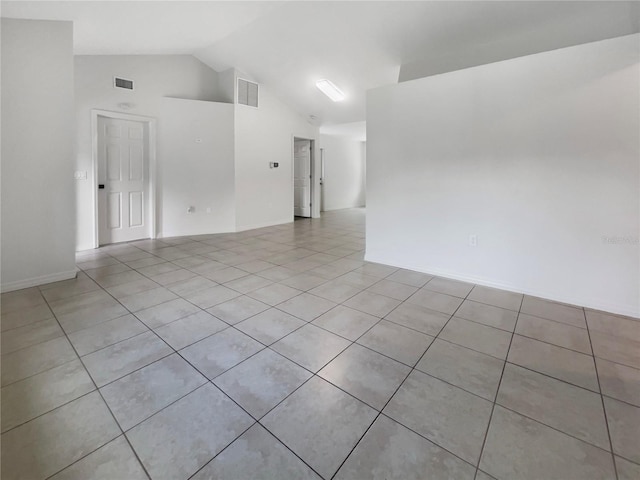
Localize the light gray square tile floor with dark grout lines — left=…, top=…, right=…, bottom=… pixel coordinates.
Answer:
left=1, top=209, right=640, bottom=480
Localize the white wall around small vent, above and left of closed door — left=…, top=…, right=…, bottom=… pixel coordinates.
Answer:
left=75, top=55, right=220, bottom=250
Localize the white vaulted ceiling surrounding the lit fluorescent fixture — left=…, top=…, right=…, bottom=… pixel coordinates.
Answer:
left=1, top=1, right=640, bottom=126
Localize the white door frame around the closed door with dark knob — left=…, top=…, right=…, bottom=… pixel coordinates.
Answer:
left=91, top=108, right=157, bottom=248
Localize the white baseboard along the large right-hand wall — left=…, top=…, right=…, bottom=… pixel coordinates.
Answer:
left=365, top=253, right=640, bottom=318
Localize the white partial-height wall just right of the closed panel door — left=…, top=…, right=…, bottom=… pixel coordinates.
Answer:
left=157, top=98, right=236, bottom=237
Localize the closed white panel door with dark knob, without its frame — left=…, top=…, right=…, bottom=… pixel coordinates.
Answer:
left=98, top=117, right=150, bottom=245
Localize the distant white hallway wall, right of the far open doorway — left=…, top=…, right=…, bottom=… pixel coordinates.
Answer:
left=320, top=135, right=366, bottom=211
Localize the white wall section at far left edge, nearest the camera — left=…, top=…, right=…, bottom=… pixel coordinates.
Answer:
left=2, top=18, right=75, bottom=291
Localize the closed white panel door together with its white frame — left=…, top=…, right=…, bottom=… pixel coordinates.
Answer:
left=91, top=110, right=156, bottom=248
